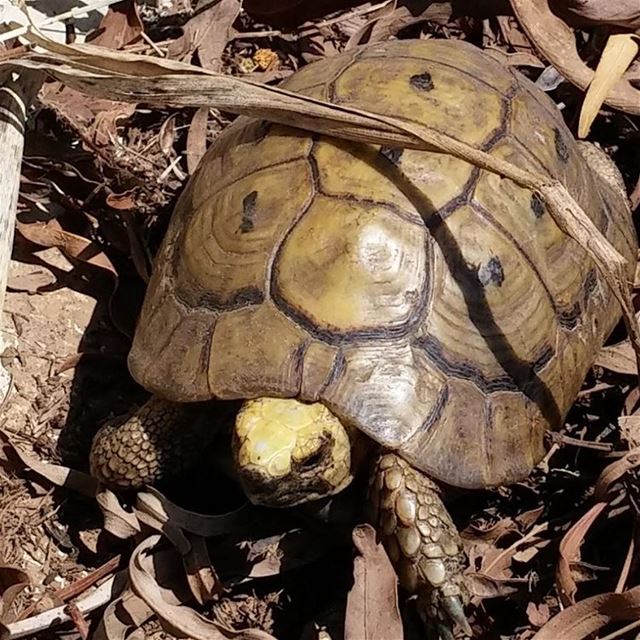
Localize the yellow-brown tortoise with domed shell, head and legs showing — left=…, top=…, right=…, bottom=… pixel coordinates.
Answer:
left=91, top=40, right=637, bottom=637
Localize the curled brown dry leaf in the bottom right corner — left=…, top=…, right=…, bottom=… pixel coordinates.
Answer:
left=532, top=587, right=640, bottom=640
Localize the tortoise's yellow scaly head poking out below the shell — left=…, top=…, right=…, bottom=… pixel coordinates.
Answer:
left=233, top=398, right=354, bottom=507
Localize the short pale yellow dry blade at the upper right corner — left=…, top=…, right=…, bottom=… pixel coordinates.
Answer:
left=578, top=33, right=640, bottom=138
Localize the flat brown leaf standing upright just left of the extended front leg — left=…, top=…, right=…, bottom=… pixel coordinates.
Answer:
left=344, top=524, right=403, bottom=640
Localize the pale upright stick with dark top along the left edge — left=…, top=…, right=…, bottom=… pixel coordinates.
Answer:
left=0, top=69, right=44, bottom=403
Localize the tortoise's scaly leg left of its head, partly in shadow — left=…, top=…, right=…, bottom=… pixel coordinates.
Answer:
left=90, top=397, right=215, bottom=488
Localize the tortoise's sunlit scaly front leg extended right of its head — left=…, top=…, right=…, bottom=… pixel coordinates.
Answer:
left=370, top=453, right=471, bottom=638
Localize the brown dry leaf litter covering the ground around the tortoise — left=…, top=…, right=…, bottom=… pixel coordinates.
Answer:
left=0, top=0, right=640, bottom=640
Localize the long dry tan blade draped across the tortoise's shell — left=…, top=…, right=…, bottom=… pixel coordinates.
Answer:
left=5, top=32, right=640, bottom=378
